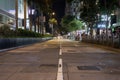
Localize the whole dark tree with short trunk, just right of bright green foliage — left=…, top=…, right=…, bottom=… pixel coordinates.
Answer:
left=80, top=0, right=99, bottom=36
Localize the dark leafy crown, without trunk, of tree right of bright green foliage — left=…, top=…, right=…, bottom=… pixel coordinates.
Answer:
left=80, top=0, right=98, bottom=22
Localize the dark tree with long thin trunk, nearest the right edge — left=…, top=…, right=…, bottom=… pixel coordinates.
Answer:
left=99, top=0, right=119, bottom=40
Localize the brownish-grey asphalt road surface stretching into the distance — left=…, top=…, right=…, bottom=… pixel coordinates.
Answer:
left=0, top=39, right=120, bottom=80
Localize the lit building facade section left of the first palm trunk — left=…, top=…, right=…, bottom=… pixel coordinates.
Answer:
left=0, top=0, right=15, bottom=24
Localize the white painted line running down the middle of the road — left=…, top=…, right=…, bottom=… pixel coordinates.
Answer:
left=57, top=42, right=63, bottom=80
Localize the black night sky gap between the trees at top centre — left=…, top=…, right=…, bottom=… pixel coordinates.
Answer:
left=53, top=0, right=65, bottom=21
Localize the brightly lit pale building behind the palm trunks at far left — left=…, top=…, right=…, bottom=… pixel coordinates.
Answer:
left=0, top=0, right=28, bottom=27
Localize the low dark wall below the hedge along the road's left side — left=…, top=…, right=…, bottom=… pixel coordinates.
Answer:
left=0, top=38, right=51, bottom=49
